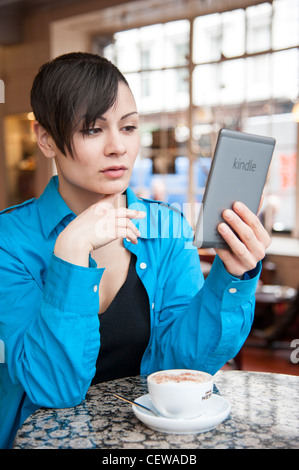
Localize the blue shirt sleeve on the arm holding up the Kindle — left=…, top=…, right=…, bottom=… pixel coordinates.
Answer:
left=149, top=226, right=261, bottom=374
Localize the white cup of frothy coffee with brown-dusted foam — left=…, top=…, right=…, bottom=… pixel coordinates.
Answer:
left=147, top=369, right=213, bottom=419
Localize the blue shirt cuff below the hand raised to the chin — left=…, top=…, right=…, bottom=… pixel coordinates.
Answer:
left=44, top=253, right=104, bottom=315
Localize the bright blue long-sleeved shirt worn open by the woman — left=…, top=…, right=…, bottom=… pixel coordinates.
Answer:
left=0, top=177, right=261, bottom=448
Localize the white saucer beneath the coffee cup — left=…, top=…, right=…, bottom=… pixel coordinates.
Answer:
left=132, top=394, right=231, bottom=434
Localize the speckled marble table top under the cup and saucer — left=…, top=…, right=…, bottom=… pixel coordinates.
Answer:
left=14, top=371, right=299, bottom=449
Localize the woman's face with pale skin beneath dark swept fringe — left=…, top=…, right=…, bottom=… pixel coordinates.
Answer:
left=55, top=82, right=140, bottom=208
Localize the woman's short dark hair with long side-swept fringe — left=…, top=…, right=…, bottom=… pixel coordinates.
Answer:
left=31, top=52, right=129, bottom=155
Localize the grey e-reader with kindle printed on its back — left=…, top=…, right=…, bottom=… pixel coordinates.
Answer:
left=193, top=129, right=275, bottom=248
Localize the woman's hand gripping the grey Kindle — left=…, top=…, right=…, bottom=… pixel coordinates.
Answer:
left=215, top=202, right=271, bottom=277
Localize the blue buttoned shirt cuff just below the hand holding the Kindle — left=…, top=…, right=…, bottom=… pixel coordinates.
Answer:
left=206, top=255, right=262, bottom=308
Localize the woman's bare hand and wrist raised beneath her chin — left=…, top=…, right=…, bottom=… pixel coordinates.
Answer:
left=54, top=195, right=146, bottom=267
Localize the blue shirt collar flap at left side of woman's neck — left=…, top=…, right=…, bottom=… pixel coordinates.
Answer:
left=37, top=176, right=75, bottom=238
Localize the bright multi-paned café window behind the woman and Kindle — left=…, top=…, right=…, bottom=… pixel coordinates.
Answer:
left=94, top=0, right=299, bottom=232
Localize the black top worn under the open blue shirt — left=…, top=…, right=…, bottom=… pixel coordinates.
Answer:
left=92, top=255, right=150, bottom=384
